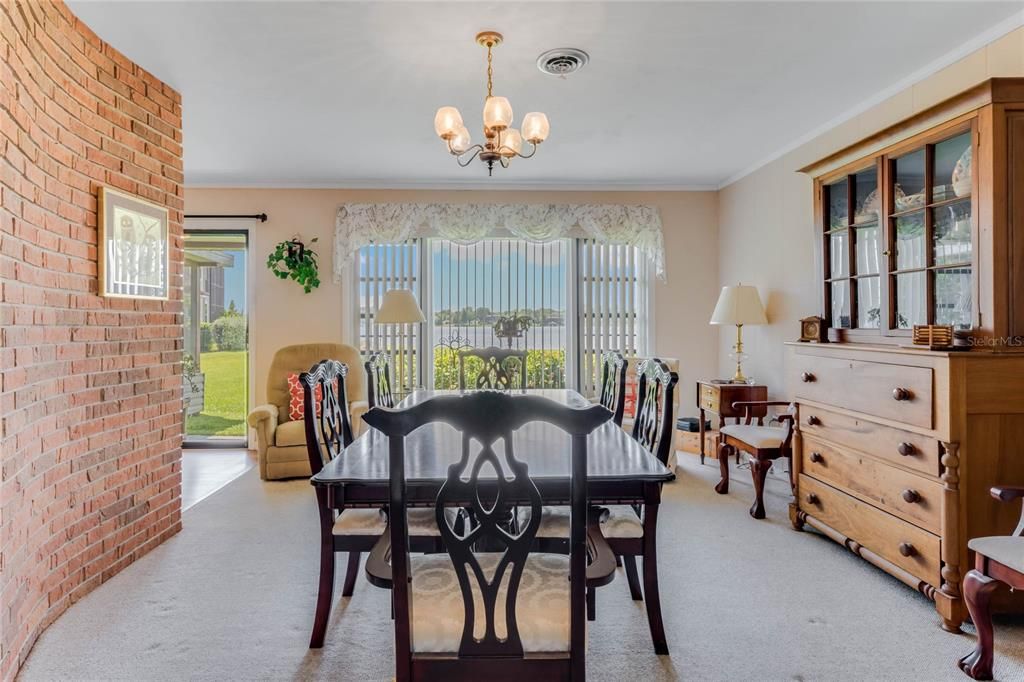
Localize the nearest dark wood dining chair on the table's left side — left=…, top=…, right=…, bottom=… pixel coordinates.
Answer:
left=299, top=359, right=439, bottom=648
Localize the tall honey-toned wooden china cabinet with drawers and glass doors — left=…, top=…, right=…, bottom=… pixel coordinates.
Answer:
left=786, top=79, right=1024, bottom=631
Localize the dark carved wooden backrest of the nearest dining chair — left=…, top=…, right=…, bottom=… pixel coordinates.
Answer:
left=364, top=391, right=611, bottom=680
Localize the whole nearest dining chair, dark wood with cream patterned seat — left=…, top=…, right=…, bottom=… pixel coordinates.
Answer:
left=366, top=391, right=615, bottom=682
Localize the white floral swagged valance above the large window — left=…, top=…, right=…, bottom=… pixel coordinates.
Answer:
left=334, top=204, right=665, bottom=282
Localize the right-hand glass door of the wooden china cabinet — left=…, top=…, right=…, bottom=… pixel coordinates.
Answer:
left=887, top=130, right=976, bottom=330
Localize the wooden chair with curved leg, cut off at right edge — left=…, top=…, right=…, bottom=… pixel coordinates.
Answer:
left=957, top=485, right=1024, bottom=680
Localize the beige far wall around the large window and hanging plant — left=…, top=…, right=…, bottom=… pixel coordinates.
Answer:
left=185, top=188, right=719, bottom=414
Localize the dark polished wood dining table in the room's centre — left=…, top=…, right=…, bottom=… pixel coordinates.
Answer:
left=310, top=389, right=675, bottom=648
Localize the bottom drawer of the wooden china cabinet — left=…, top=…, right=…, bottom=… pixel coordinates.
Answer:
left=799, top=474, right=941, bottom=585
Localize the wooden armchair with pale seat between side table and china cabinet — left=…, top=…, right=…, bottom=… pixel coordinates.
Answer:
left=715, top=400, right=797, bottom=518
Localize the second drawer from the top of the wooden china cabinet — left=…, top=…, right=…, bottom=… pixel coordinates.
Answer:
left=800, top=404, right=940, bottom=476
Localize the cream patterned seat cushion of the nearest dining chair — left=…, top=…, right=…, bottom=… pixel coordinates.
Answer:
left=410, top=553, right=569, bottom=653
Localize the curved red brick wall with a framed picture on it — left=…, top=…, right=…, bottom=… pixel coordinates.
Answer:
left=0, top=0, right=183, bottom=680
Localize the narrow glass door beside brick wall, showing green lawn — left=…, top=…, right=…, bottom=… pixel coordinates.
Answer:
left=184, top=229, right=249, bottom=447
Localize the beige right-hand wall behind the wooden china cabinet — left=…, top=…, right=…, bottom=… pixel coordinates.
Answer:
left=719, top=28, right=1024, bottom=397
